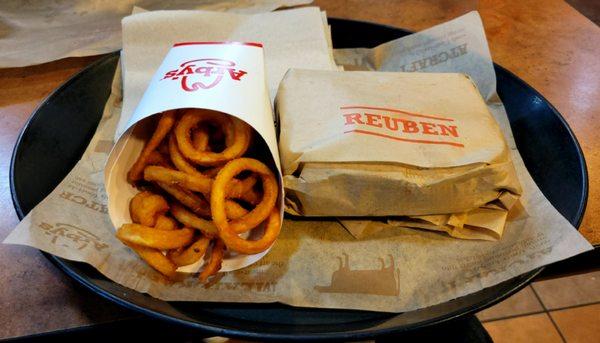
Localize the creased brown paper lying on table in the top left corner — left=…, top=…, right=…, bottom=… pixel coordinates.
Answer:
left=0, top=0, right=312, bottom=68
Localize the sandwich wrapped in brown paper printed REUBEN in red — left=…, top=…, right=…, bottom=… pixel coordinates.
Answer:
left=276, top=70, right=521, bottom=217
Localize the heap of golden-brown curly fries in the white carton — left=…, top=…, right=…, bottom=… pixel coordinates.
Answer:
left=116, top=109, right=282, bottom=282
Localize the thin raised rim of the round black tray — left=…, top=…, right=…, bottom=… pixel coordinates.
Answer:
left=9, top=17, right=597, bottom=341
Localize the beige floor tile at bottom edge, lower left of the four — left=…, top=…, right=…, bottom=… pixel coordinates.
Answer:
left=483, top=313, right=562, bottom=343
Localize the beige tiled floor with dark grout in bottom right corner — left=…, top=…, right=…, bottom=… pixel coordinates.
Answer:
left=477, top=271, right=600, bottom=343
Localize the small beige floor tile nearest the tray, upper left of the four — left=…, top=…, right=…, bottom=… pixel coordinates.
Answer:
left=477, top=286, right=544, bottom=322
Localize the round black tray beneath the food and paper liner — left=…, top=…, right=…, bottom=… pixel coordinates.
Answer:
left=10, top=19, right=588, bottom=340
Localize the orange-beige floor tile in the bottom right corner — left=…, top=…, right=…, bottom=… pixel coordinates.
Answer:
left=550, top=304, right=600, bottom=343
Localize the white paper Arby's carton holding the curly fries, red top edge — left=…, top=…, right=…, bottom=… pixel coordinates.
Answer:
left=104, top=42, right=283, bottom=272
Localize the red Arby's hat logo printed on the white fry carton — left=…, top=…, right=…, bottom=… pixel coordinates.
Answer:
left=161, top=58, right=248, bottom=92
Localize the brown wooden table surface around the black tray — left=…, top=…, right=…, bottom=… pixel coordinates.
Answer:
left=0, top=0, right=600, bottom=339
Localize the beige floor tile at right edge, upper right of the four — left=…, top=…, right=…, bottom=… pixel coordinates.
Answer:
left=533, top=271, right=600, bottom=310
